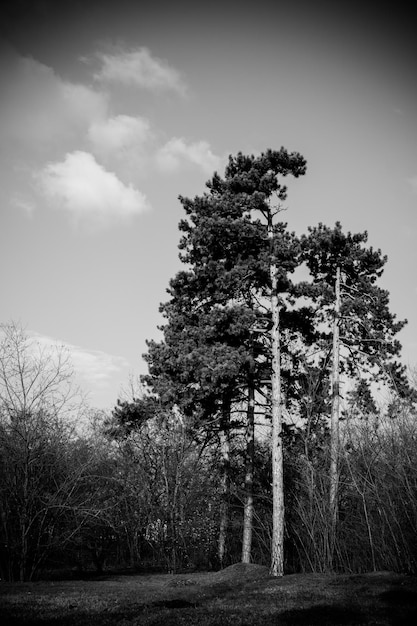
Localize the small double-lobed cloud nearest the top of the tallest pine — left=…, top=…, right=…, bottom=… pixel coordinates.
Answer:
left=156, top=137, right=221, bottom=175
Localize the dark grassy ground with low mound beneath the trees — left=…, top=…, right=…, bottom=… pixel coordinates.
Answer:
left=0, top=565, right=417, bottom=626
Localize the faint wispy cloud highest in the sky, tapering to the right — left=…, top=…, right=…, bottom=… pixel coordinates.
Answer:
left=94, top=48, right=186, bottom=95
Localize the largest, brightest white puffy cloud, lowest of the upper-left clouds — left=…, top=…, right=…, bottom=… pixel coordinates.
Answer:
left=38, top=151, right=149, bottom=226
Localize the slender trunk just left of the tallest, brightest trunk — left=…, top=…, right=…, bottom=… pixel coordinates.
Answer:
left=242, top=368, right=255, bottom=563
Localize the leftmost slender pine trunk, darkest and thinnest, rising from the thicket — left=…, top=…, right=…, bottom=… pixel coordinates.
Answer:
left=218, top=402, right=230, bottom=567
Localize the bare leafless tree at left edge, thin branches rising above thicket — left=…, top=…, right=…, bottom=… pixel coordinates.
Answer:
left=0, top=323, right=83, bottom=580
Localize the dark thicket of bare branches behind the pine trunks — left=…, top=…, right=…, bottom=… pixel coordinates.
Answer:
left=0, top=330, right=417, bottom=580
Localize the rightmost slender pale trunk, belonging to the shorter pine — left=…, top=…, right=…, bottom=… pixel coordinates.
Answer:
left=329, top=267, right=340, bottom=569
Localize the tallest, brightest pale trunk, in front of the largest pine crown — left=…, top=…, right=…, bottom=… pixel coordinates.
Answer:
left=268, top=213, right=284, bottom=576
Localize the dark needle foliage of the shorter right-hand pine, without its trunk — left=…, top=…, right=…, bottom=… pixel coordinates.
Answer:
left=302, top=222, right=411, bottom=395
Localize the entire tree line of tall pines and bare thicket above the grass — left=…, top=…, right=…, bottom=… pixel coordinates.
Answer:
left=0, top=148, right=417, bottom=579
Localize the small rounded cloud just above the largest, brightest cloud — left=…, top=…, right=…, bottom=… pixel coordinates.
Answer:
left=88, top=115, right=150, bottom=156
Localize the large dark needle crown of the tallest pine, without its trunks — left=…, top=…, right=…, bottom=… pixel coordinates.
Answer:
left=144, top=148, right=311, bottom=419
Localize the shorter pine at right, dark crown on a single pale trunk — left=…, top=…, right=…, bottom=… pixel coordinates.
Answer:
left=302, top=222, right=408, bottom=569
